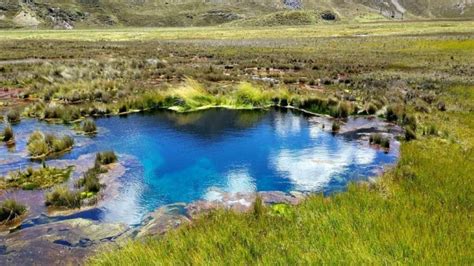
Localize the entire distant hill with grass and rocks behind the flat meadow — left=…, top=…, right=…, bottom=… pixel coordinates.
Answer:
left=0, top=0, right=474, bottom=28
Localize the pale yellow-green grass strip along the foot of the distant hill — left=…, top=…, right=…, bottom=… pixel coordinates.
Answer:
left=0, top=21, right=474, bottom=41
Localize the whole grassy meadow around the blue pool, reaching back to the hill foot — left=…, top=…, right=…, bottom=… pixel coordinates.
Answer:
left=0, top=21, right=474, bottom=265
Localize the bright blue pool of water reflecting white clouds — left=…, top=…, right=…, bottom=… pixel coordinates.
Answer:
left=0, top=109, right=398, bottom=224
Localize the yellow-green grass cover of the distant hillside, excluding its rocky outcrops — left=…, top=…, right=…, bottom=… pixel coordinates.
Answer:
left=0, top=0, right=474, bottom=28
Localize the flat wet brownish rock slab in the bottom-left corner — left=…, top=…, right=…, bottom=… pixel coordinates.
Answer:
left=0, top=219, right=128, bottom=265
